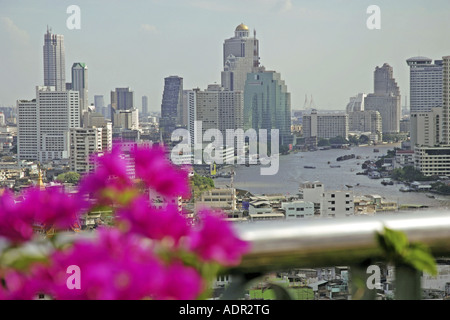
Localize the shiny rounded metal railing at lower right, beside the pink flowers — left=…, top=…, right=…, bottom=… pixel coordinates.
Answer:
left=229, top=210, right=450, bottom=300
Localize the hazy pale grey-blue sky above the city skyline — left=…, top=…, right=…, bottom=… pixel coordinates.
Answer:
left=0, top=0, right=450, bottom=111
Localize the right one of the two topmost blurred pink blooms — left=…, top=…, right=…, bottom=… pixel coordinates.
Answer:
left=133, top=146, right=190, bottom=198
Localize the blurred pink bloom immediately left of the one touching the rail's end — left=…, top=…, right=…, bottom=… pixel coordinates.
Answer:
left=118, top=196, right=190, bottom=245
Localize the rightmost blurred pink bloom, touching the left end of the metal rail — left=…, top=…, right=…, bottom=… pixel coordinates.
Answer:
left=189, top=210, right=250, bottom=266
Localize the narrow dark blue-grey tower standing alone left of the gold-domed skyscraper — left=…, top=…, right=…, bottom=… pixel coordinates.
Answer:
left=159, top=76, right=183, bottom=144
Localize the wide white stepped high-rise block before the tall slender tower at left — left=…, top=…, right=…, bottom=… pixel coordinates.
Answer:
left=17, top=86, right=80, bottom=162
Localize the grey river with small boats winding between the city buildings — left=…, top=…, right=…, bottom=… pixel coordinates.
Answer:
left=215, top=144, right=450, bottom=208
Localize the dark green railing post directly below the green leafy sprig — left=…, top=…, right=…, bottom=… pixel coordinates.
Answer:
left=395, top=264, right=422, bottom=300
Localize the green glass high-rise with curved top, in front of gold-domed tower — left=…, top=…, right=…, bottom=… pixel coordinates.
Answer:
left=244, top=68, right=292, bottom=145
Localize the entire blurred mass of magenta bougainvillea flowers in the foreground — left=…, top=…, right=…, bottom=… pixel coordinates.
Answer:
left=0, top=146, right=249, bottom=300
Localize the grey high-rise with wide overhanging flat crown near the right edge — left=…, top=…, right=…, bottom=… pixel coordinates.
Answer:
left=406, top=57, right=443, bottom=113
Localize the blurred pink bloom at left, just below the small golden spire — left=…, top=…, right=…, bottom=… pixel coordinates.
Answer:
left=20, top=188, right=84, bottom=230
